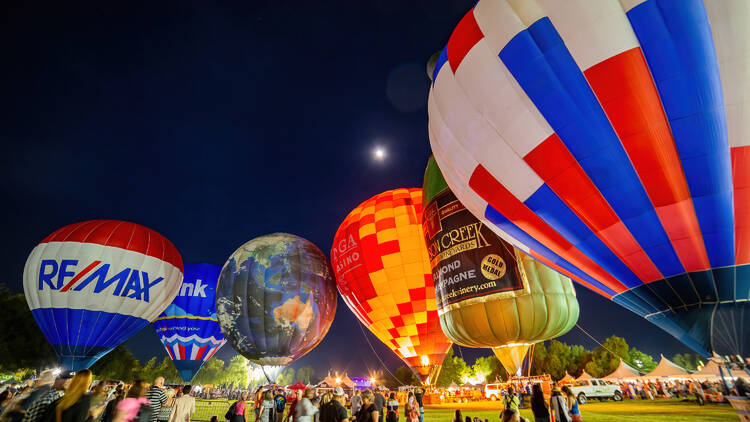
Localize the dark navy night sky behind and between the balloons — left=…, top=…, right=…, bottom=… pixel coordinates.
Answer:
left=0, top=0, right=688, bottom=376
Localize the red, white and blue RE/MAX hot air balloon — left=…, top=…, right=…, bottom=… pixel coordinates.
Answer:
left=23, top=220, right=183, bottom=371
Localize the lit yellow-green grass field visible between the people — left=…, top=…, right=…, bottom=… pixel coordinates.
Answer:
left=192, top=400, right=739, bottom=422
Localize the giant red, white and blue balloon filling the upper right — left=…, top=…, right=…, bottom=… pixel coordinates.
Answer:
left=428, top=0, right=750, bottom=356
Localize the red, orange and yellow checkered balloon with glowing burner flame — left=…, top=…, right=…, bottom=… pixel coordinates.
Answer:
left=331, top=189, right=451, bottom=384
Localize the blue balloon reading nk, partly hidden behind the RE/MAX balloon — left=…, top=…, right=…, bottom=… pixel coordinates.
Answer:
left=154, top=264, right=227, bottom=382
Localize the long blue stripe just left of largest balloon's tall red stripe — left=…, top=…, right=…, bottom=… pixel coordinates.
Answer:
left=499, top=17, right=685, bottom=278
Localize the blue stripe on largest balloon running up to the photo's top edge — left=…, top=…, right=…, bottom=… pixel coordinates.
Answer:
left=627, top=0, right=735, bottom=267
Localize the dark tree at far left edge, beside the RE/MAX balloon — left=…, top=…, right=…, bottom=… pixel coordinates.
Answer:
left=0, top=285, right=57, bottom=371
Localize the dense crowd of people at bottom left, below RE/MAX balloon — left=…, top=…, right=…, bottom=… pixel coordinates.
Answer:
left=0, top=369, right=195, bottom=422
